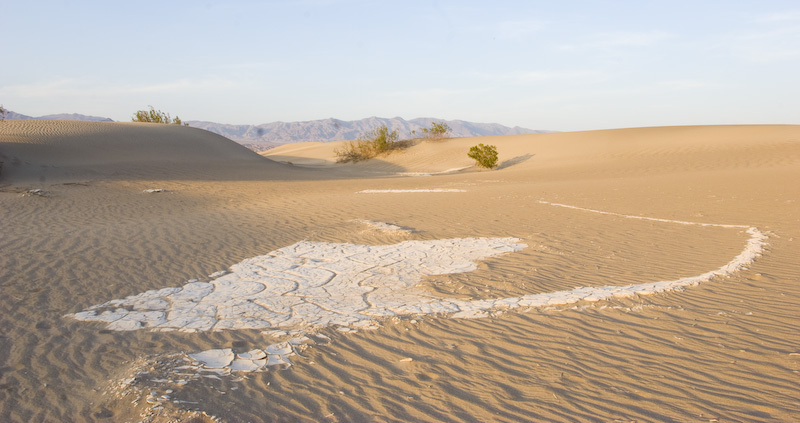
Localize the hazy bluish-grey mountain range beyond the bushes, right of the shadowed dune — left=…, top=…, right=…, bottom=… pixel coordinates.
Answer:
left=188, top=117, right=550, bottom=151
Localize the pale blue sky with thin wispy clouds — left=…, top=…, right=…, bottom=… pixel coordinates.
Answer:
left=0, top=0, right=800, bottom=131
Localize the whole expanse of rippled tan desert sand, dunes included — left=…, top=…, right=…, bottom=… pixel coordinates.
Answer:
left=0, top=121, right=800, bottom=422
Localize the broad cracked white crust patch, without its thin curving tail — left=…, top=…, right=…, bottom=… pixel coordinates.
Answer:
left=70, top=238, right=526, bottom=332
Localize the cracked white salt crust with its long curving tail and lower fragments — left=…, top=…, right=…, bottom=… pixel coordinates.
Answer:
left=68, top=205, right=767, bottom=372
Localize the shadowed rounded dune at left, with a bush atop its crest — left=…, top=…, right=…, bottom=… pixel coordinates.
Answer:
left=0, top=120, right=272, bottom=179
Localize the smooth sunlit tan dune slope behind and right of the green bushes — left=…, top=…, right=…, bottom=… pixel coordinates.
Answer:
left=261, top=125, right=798, bottom=177
